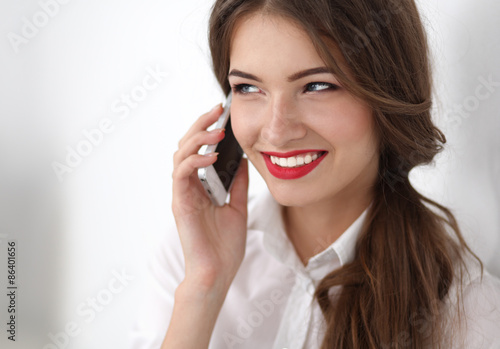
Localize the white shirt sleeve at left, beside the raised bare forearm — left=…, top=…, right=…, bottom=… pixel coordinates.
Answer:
left=130, top=227, right=184, bottom=349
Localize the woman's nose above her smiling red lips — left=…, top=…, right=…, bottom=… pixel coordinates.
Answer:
left=261, top=96, right=307, bottom=148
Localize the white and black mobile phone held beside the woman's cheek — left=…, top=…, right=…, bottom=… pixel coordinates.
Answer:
left=198, top=93, right=243, bottom=206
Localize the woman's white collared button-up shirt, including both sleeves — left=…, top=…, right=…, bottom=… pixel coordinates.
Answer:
left=131, top=192, right=500, bottom=349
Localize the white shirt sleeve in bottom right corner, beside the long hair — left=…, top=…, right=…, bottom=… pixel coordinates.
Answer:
left=463, top=271, right=500, bottom=349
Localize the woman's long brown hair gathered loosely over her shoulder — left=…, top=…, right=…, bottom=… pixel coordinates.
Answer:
left=209, top=0, right=482, bottom=349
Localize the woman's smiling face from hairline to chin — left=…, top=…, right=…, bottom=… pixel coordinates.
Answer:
left=228, top=14, right=378, bottom=206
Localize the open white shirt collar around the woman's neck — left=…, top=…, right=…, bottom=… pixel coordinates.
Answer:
left=249, top=190, right=369, bottom=280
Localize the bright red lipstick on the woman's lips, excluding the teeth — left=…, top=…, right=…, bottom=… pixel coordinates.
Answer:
left=261, top=149, right=328, bottom=179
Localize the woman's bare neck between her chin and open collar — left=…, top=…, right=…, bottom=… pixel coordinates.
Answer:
left=283, top=189, right=373, bottom=265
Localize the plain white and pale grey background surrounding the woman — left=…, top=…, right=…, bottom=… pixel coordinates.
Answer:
left=0, top=0, right=500, bottom=349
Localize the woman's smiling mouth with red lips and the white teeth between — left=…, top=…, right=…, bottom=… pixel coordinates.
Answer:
left=261, top=149, right=328, bottom=179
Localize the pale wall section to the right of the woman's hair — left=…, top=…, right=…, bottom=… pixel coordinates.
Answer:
left=415, top=0, right=500, bottom=275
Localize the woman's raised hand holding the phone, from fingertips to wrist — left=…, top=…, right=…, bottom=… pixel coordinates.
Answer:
left=172, top=105, right=248, bottom=293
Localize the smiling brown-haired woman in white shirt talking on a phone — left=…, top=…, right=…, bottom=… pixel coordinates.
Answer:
left=132, top=0, right=500, bottom=349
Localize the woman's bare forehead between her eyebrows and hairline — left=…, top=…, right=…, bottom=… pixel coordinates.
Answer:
left=230, top=13, right=325, bottom=72
